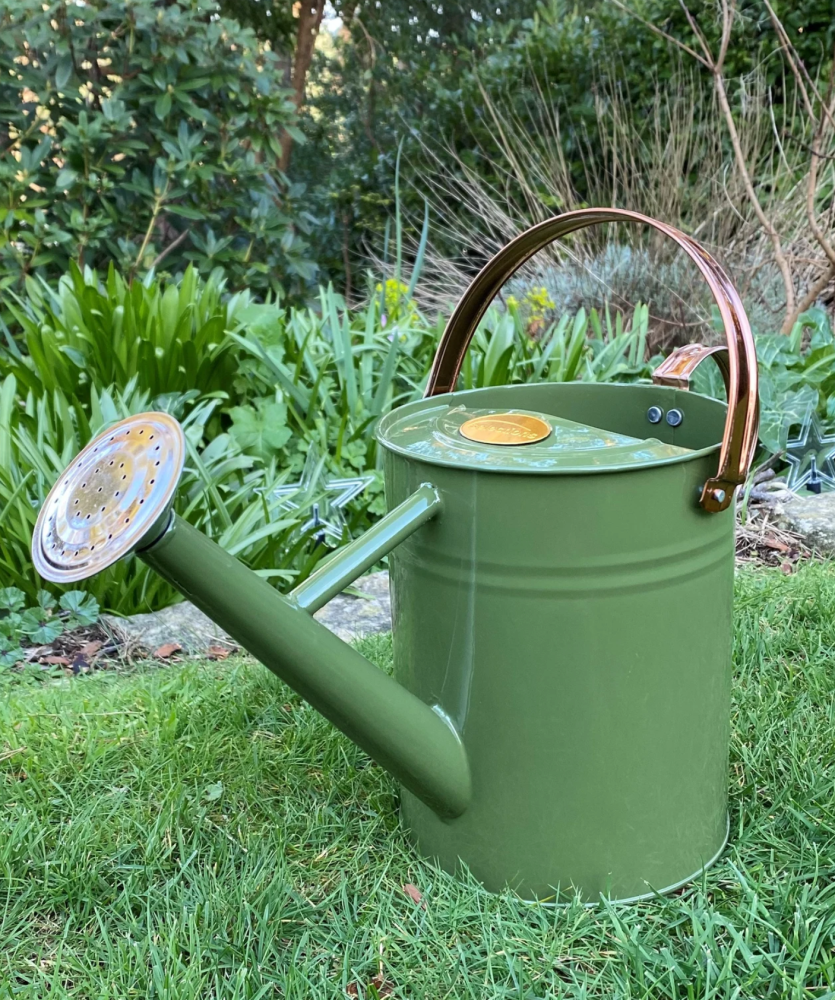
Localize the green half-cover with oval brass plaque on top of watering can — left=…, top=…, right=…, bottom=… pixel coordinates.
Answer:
left=381, top=404, right=690, bottom=473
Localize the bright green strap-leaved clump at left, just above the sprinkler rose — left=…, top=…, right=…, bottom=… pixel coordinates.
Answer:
left=0, top=263, right=250, bottom=408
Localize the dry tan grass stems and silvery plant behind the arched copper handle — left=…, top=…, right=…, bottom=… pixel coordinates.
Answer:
left=406, top=9, right=835, bottom=349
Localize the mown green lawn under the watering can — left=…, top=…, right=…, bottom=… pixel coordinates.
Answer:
left=0, top=565, right=835, bottom=1000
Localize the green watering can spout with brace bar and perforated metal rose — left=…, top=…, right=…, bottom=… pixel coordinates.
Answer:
left=33, top=414, right=470, bottom=818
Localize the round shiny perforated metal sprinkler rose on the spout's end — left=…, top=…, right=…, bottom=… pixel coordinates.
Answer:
left=32, top=413, right=185, bottom=583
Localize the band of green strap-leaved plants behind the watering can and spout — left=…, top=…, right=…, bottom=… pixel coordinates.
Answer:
left=0, top=267, right=668, bottom=613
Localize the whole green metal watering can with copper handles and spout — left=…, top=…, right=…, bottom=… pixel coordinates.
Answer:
left=33, top=209, right=758, bottom=901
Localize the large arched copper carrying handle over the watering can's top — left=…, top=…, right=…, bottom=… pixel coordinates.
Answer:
left=425, top=208, right=759, bottom=513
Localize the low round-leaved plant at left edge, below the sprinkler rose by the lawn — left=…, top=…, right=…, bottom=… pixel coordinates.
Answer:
left=0, top=587, right=99, bottom=667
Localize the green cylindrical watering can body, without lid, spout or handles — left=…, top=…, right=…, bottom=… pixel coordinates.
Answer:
left=380, top=383, right=733, bottom=899
